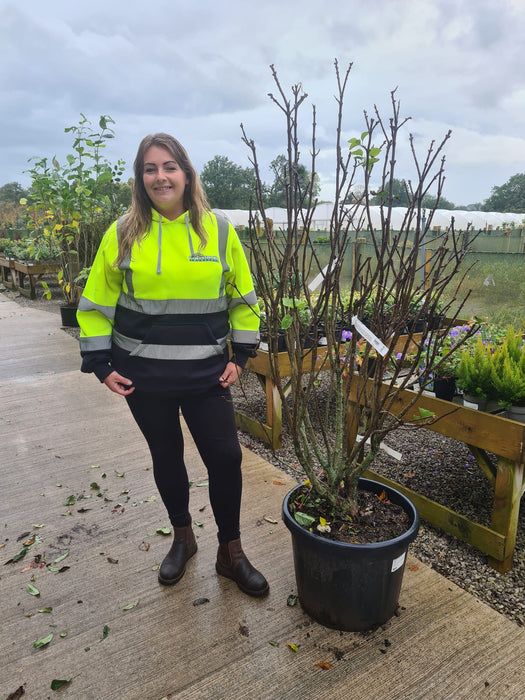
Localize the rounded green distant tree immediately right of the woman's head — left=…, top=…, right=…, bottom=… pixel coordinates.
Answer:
left=200, top=156, right=254, bottom=209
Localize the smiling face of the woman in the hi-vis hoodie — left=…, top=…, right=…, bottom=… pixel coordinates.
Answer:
left=142, top=146, right=188, bottom=220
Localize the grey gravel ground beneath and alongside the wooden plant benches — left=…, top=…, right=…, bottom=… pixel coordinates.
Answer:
left=0, top=285, right=525, bottom=626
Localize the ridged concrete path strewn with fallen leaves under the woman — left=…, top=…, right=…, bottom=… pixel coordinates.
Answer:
left=0, top=295, right=525, bottom=700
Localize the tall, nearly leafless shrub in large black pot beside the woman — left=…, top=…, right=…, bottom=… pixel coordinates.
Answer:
left=241, top=62, right=476, bottom=630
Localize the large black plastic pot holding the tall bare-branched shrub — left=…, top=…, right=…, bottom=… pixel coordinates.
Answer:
left=282, top=479, right=419, bottom=632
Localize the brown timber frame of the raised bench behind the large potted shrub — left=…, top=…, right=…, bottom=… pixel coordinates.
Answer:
left=236, top=349, right=525, bottom=573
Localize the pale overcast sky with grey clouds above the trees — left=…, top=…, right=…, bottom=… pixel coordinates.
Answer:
left=0, top=0, right=525, bottom=204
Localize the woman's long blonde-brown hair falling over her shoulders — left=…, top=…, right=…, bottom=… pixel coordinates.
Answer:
left=116, top=133, right=210, bottom=265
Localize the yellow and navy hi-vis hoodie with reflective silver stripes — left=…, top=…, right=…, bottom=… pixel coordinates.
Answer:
left=77, top=210, right=259, bottom=393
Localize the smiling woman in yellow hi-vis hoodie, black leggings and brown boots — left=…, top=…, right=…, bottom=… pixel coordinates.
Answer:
left=77, top=134, right=268, bottom=596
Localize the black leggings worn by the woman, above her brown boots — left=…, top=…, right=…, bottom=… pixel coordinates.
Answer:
left=126, top=387, right=242, bottom=542
